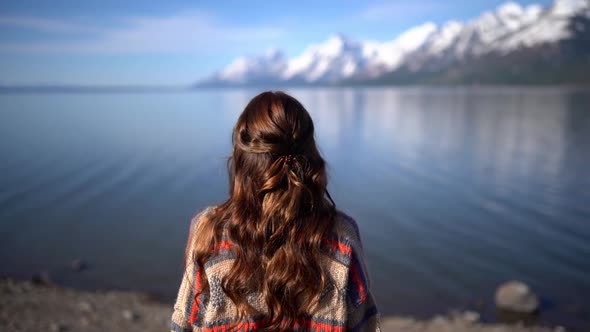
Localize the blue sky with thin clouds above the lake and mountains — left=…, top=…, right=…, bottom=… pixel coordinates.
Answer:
left=0, top=0, right=551, bottom=85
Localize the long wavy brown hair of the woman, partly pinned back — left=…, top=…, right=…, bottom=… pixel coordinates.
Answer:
left=189, top=92, right=336, bottom=331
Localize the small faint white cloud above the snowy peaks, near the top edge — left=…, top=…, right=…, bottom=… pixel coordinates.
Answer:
left=360, top=1, right=444, bottom=21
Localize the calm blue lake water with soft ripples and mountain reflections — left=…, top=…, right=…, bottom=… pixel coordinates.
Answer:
left=0, top=88, right=590, bottom=328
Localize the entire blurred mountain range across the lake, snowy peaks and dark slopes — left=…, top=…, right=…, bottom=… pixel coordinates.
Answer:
left=196, top=0, right=590, bottom=86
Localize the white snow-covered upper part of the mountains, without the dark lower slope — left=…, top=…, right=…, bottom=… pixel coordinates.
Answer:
left=200, top=0, right=590, bottom=85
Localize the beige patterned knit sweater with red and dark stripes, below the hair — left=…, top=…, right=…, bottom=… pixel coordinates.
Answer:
left=171, top=207, right=380, bottom=332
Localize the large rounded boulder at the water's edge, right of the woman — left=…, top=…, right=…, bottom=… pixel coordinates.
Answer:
left=495, top=280, right=539, bottom=314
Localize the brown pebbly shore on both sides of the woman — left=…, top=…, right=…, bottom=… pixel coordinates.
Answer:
left=0, top=278, right=566, bottom=332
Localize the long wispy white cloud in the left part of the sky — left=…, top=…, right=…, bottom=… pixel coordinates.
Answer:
left=0, top=13, right=284, bottom=54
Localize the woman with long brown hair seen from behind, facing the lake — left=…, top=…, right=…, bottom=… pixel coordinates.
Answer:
left=171, top=92, right=379, bottom=331
